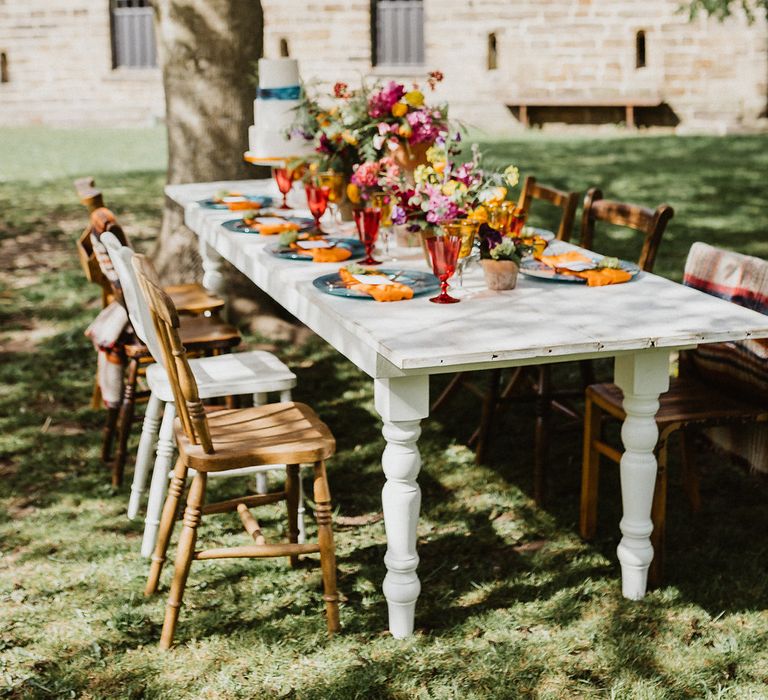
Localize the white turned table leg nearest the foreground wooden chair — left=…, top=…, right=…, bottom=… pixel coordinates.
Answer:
left=374, top=375, right=429, bottom=639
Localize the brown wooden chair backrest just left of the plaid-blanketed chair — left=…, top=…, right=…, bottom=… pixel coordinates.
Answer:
left=579, top=187, right=675, bottom=272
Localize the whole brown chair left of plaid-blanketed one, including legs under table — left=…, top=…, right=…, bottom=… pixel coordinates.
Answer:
left=477, top=188, right=674, bottom=505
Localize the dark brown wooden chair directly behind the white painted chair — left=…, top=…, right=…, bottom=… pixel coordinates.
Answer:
left=84, top=208, right=241, bottom=488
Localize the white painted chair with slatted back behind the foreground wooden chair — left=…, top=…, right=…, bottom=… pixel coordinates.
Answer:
left=101, top=233, right=304, bottom=557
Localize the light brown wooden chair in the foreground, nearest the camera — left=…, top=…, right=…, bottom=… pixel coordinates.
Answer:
left=133, top=255, right=339, bottom=649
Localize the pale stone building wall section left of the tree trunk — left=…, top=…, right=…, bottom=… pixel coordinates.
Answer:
left=0, top=0, right=165, bottom=126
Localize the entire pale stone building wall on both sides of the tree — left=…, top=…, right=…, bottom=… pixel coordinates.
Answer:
left=0, top=0, right=768, bottom=131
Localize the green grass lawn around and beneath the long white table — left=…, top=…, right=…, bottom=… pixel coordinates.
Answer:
left=0, top=129, right=768, bottom=700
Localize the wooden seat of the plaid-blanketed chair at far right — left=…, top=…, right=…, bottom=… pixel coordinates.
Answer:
left=587, top=379, right=768, bottom=429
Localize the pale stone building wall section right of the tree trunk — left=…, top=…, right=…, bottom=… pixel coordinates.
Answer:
left=262, top=0, right=768, bottom=132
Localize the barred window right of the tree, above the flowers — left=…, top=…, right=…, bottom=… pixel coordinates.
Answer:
left=371, top=0, right=424, bottom=66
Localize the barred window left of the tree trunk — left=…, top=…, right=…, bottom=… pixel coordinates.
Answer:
left=110, top=0, right=157, bottom=68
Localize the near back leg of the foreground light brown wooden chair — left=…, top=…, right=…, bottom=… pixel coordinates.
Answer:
left=160, top=472, right=208, bottom=649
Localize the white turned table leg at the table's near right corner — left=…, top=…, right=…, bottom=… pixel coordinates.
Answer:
left=614, top=350, right=669, bottom=600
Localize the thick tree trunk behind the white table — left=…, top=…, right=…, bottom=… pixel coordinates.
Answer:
left=154, top=0, right=263, bottom=282
